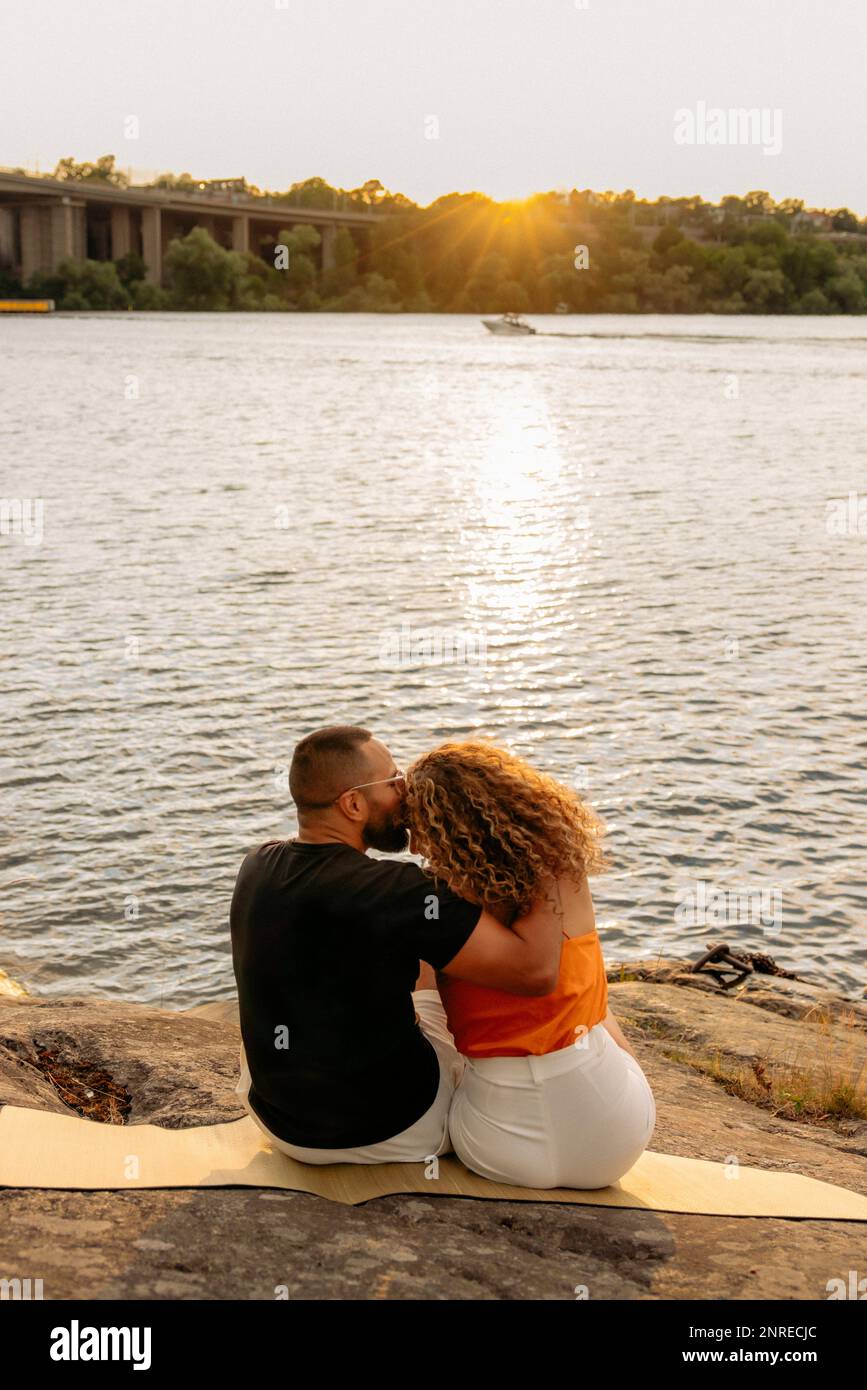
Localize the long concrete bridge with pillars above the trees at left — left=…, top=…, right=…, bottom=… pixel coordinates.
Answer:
left=0, top=170, right=381, bottom=285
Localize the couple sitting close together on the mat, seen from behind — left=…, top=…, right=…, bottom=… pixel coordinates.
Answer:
left=231, top=726, right=656, bottom=1188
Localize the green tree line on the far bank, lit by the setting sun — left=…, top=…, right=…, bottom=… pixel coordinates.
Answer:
left=6, top=156, right=867, bottom=314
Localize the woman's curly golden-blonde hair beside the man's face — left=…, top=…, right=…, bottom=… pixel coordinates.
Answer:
left=406, top=739, right=607, bottom=912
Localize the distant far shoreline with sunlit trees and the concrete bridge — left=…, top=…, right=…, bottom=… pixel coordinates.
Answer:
left=6, top=182, right=867, bottom=316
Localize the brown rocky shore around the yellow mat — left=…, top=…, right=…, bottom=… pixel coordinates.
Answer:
left=0, top=959, right=867, bottom=1300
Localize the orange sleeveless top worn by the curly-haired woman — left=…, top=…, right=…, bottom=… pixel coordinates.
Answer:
left=436, top=927, right=609, bottom=1056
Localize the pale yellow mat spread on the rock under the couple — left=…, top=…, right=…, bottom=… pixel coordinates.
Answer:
left=0, top=1105, right=867, bottom=1220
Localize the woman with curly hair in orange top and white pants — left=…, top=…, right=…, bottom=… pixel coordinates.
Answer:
left=406, top=741, right=656, bottom=1188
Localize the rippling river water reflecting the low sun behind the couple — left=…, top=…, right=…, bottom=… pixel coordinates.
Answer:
left=0, top=314, right=867, bottom=1006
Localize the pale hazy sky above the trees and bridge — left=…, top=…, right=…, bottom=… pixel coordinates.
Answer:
left=0, top=0, right=867, bottom=215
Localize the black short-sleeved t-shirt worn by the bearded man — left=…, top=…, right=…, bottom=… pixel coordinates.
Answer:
left=231, top=840, right=481, bottom=1148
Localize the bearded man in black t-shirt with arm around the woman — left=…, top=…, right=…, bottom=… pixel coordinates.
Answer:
left=231, top=726, right=561, bottom=1163
